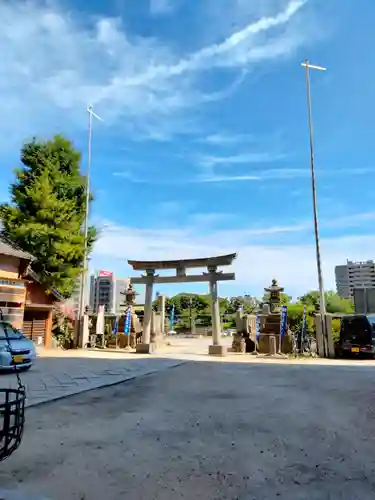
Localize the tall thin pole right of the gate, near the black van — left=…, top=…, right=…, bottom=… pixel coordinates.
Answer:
left=306, top=59, right=328, bottom=356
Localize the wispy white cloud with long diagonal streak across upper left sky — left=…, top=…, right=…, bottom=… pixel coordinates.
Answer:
left=0, top=0, right=312, bottom=144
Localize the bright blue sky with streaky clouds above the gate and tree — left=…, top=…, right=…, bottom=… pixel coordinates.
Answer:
left=0, top=0, right=375, bottom=296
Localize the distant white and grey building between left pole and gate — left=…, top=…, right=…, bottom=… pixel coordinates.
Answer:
left=90, top=271, right=130, bottom=314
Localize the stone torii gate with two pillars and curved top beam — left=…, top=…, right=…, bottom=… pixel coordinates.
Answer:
left=128, top=253, right=237, bottom=356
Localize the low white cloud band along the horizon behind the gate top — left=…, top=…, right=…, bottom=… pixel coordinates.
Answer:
left=93, top=216, right=375, bottom=296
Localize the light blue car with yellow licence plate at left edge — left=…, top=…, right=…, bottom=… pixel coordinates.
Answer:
left=0, top=321, right=36, bottom=370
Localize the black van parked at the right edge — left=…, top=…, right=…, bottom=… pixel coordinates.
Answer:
left=340, top=314, right=375, bottom=356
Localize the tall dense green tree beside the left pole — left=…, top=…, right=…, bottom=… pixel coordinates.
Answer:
left=0, top=136, right=96, bottom=297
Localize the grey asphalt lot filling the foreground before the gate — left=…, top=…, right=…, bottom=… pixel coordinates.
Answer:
left=0, top=362, right=375, bottom=500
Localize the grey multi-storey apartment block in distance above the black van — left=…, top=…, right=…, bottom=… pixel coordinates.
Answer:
left=335, top=260, right=375, bottom=299
